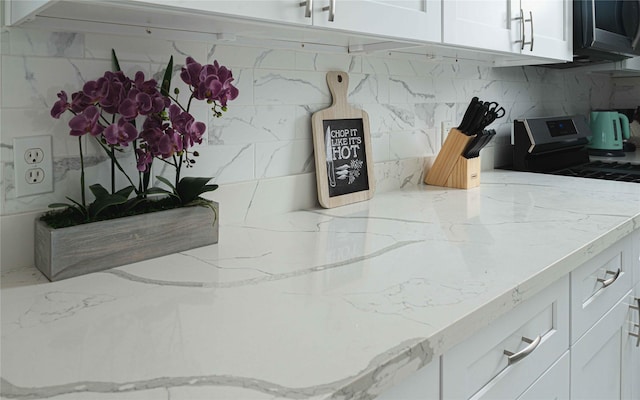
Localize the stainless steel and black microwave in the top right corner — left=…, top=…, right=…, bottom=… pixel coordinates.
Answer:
left=573, top=0, right=640, bottom=64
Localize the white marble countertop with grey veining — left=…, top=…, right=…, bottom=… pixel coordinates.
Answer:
left=1, top=170, right=640, bottom=400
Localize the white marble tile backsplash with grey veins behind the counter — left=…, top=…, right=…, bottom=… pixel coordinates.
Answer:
left=0, top=24, right=612, bottom=269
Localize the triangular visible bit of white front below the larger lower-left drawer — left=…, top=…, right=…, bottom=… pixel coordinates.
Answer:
left=517, top=351, right=570, bottom=400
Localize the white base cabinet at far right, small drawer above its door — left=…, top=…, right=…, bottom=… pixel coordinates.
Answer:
left=571, top=233, right=640, bottom=400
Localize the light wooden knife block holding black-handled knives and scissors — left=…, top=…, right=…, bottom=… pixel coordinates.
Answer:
left=424, top=128, right=480, bottom=189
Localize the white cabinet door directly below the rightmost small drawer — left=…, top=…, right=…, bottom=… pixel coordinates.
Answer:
left=571, top=291, right=631, bottom=400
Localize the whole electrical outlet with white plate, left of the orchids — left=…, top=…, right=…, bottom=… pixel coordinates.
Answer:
left=13, top=135, right=53, bottom=197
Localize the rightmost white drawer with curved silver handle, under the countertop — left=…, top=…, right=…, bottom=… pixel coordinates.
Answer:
left=571, top=235, right=634, bottom=343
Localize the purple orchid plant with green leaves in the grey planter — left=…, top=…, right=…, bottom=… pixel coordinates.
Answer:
left=50, top=52, right=238, bottom=227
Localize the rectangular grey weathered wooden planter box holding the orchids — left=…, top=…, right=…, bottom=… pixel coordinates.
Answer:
left=35, top=202, right=218, bottom=281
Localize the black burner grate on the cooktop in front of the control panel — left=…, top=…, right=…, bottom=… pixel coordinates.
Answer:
left=551, top=161, right=640, bottom=183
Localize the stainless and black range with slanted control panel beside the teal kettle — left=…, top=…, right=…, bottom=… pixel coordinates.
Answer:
left=512, top=116, right=640, bottom=183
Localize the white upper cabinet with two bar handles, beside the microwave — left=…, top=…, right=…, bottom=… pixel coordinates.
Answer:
left=442, top=0, right=573, bottom=62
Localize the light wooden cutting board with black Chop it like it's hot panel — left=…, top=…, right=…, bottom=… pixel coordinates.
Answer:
left=311, top=71, right=375, bottom=208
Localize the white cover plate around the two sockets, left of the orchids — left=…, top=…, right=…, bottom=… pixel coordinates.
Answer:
left=13, top=135, right=53, bottom=197
